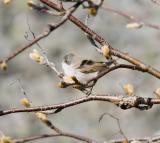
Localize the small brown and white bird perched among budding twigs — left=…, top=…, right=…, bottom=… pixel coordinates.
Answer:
left=62, top=53, right=113, bottom=84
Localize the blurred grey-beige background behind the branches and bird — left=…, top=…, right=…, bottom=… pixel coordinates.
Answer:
left=0, top=0, right=160, bottom=143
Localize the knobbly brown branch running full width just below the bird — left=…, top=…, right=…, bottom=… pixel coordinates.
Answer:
left=0, top=95, right=160, bottom=116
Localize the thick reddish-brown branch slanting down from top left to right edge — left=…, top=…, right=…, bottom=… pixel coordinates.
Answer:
left=40, top=0, right=160, bottom=79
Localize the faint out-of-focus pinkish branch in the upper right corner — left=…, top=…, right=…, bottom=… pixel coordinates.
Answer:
left=101, top=6, right=160, bottom=30
